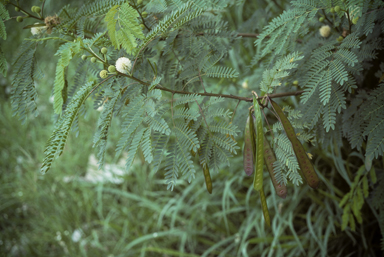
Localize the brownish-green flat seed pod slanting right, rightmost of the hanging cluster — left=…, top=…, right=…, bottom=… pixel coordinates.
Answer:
left=271, top=100, right=320, bottom=188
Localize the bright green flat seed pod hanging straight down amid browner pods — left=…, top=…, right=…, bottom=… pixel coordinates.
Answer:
left=250, top=95, right=264, bottom=191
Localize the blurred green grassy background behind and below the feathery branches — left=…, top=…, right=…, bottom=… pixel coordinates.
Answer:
left=0, top=0, right=382, bottom=257
